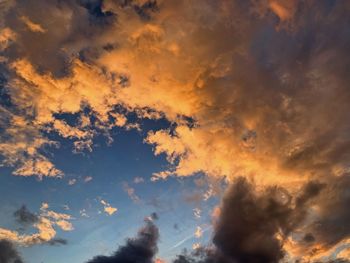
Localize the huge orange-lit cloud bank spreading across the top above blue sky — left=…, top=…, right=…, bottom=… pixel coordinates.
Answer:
left=1, top=0, right=349, bottom=186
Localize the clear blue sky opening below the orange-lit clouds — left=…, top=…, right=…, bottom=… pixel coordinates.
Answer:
left=0, top=116, right=217, bottom=263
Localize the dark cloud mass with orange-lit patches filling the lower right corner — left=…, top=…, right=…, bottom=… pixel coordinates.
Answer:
left=174, top=177, right=349, bottom=263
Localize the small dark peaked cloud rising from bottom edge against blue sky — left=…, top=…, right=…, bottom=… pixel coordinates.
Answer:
left=87, top=220, right=159, bottom=263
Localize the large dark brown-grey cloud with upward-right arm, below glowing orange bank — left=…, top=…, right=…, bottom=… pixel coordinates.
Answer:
left=213, top=178, right=320, bottom=263
